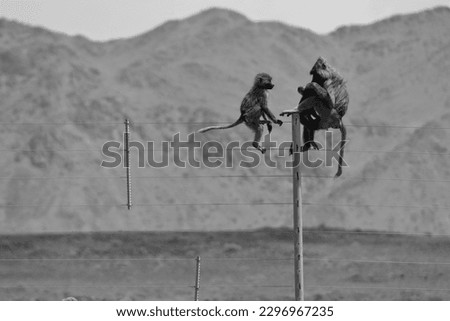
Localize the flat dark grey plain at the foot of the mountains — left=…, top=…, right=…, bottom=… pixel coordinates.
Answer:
left=0, top=229, right=450, bottom=300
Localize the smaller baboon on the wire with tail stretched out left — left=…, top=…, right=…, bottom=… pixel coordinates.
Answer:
left=198, top=73, right=283, bottom=154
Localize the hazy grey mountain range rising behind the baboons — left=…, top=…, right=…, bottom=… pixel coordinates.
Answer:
left=0, top=7, right=450, bottom=233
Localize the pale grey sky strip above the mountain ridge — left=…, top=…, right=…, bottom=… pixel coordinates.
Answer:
left=0, top=0, right=450, bottom=41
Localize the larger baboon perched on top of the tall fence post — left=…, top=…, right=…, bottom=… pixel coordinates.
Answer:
left=281, top=57, right=349, bottom=177
